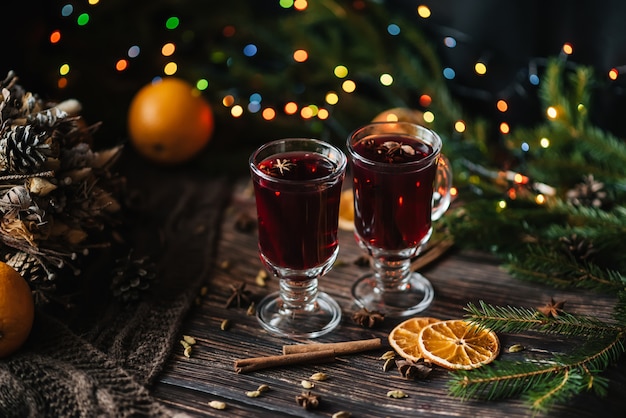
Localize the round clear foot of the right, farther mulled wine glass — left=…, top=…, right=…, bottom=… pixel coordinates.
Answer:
left=352, top=272, right=435, bottom=317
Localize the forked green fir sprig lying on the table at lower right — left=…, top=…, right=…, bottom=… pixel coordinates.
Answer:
left=449, top=301, right=626, bottom=412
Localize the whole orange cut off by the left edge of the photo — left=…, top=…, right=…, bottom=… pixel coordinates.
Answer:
left=0, top=262, right=35, bottom=358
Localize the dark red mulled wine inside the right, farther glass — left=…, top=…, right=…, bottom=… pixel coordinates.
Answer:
left=352, top=135, right=437, bottom=250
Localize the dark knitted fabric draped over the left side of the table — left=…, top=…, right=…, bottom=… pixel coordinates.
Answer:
left=0, top=158, right=228, bottom=418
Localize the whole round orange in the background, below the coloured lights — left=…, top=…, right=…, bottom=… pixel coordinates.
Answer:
left=128, top=77, right=214, bottom=165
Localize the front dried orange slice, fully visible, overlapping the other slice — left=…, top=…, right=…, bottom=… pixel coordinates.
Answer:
left=418, top=319, right=500, bottom=370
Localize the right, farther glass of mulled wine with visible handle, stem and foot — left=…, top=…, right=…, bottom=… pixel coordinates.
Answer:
left=347, top=122, right=452, bottom=317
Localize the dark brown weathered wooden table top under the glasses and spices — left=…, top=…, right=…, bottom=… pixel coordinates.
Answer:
left=151, top=181, right=626, bottom=417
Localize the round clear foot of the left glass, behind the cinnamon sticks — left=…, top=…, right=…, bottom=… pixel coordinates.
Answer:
left=256, top=292, right=341, bottom=338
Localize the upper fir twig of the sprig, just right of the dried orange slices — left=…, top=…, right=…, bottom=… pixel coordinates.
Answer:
left=465, top=301, right=626, bottom=337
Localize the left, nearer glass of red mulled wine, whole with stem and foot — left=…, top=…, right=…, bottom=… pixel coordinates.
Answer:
left=250, top=138, right=347, bottom=338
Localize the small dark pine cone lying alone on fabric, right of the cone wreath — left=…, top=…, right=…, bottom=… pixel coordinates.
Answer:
left=111, top=255, right=156, bottom=303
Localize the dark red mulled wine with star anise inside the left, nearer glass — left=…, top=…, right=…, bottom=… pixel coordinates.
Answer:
left=254, top=152, right=343, bottom=270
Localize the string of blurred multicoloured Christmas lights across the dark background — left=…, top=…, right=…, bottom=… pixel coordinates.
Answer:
left=49, top=0, right=626, bottom=147
